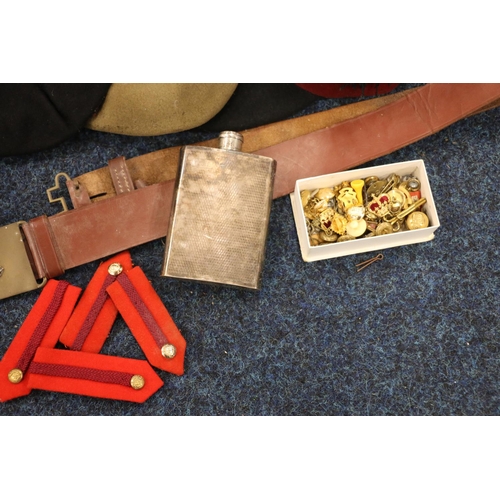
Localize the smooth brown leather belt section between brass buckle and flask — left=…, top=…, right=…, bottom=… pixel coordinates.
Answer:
left=22, top=181, right=174, bottom=279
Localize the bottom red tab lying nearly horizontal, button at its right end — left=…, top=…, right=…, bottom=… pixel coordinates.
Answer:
left=28, top=348, right=163, bottom=403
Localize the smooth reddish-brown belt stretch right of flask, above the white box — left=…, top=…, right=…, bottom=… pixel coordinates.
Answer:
left=257, top=84, right=500, bottom=198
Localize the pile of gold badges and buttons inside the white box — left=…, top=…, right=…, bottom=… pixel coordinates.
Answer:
left=300, top=174, right=429, bottom=246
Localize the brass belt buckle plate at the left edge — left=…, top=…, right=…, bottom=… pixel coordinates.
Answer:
left=0, top=221, right=47, bottom=300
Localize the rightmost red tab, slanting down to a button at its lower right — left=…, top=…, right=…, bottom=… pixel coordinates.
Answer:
left=107, top=267, right=186, bottom=375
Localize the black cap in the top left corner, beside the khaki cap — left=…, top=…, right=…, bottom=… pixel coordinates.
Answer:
left=0, top=83, right=110, bottom=156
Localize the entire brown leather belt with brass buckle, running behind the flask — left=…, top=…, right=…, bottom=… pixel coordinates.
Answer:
left=0, top=84, right=500, bottom=299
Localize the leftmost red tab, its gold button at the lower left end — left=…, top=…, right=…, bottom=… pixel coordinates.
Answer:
left=0, top=280, right=81, bottom=401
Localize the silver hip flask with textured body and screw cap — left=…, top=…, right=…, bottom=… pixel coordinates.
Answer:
left=162, top=132, right=276, bottom=290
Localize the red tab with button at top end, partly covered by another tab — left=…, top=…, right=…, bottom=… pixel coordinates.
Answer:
left=59, top=251, right=132, bottom=353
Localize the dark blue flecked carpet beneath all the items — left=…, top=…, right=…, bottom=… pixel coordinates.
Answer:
left=0, top=85, right=500, bottom=416
